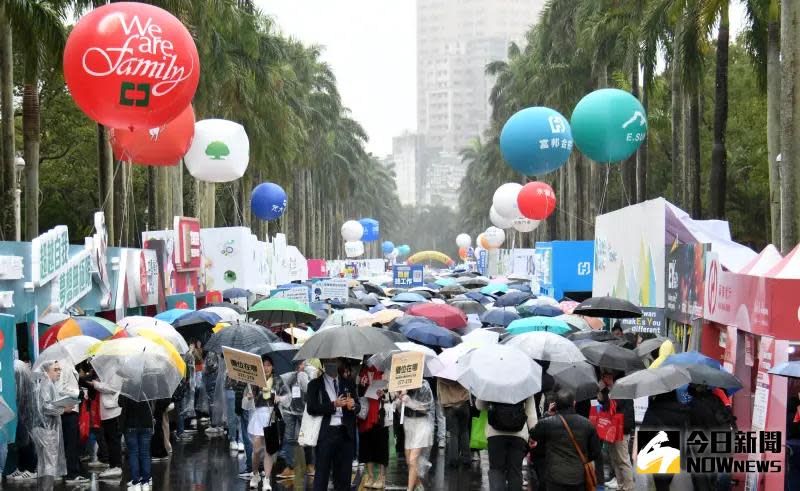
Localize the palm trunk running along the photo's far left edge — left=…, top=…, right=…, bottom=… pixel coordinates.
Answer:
left=0, top=3, right=16, bottom=240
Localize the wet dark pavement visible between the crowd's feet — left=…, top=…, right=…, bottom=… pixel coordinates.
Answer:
left=28, top=433, right=504, bottom=491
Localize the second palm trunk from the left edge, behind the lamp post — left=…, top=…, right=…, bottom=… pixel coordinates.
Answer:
left=22, top=74, right=41, bottom=241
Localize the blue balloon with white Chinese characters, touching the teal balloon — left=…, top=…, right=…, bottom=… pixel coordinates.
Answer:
left=500, top=107, right=573, bottom=176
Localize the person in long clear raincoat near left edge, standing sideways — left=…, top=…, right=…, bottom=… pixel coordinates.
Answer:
left=31, top=361, right=70, bottom=479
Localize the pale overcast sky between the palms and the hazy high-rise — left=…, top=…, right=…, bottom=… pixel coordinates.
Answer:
left=256, top=0, right=744, bottom=157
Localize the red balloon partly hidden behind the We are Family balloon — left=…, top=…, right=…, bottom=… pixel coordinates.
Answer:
left=109, top=105, right=194, bottom=165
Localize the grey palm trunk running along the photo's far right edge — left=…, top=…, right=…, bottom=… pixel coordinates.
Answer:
left=780, top=2, right=800, bottom=254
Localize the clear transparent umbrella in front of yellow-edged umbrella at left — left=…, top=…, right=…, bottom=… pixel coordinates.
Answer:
left=91, top=337, right=186, bottom=401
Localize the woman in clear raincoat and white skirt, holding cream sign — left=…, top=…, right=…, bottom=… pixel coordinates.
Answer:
left=395, top=380, right=436, bottom=491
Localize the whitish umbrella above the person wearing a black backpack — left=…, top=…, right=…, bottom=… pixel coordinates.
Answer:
left=458, top=344, right=542, bottom=404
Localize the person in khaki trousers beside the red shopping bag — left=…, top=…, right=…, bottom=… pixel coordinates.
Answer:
left=597, top=371, right=636, bottom=491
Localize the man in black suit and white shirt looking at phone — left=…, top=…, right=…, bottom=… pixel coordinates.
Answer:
left=306, top=359, right=360, bottom=491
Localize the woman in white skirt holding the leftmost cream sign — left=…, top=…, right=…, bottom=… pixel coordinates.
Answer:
left=247, top=355, right=286, bottom=491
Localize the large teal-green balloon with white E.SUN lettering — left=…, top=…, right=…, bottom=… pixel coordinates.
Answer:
left=570, top=89, right=647, bottom=163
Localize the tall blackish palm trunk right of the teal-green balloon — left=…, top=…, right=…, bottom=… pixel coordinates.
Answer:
left=708, top=2, right=730, bottom=218
